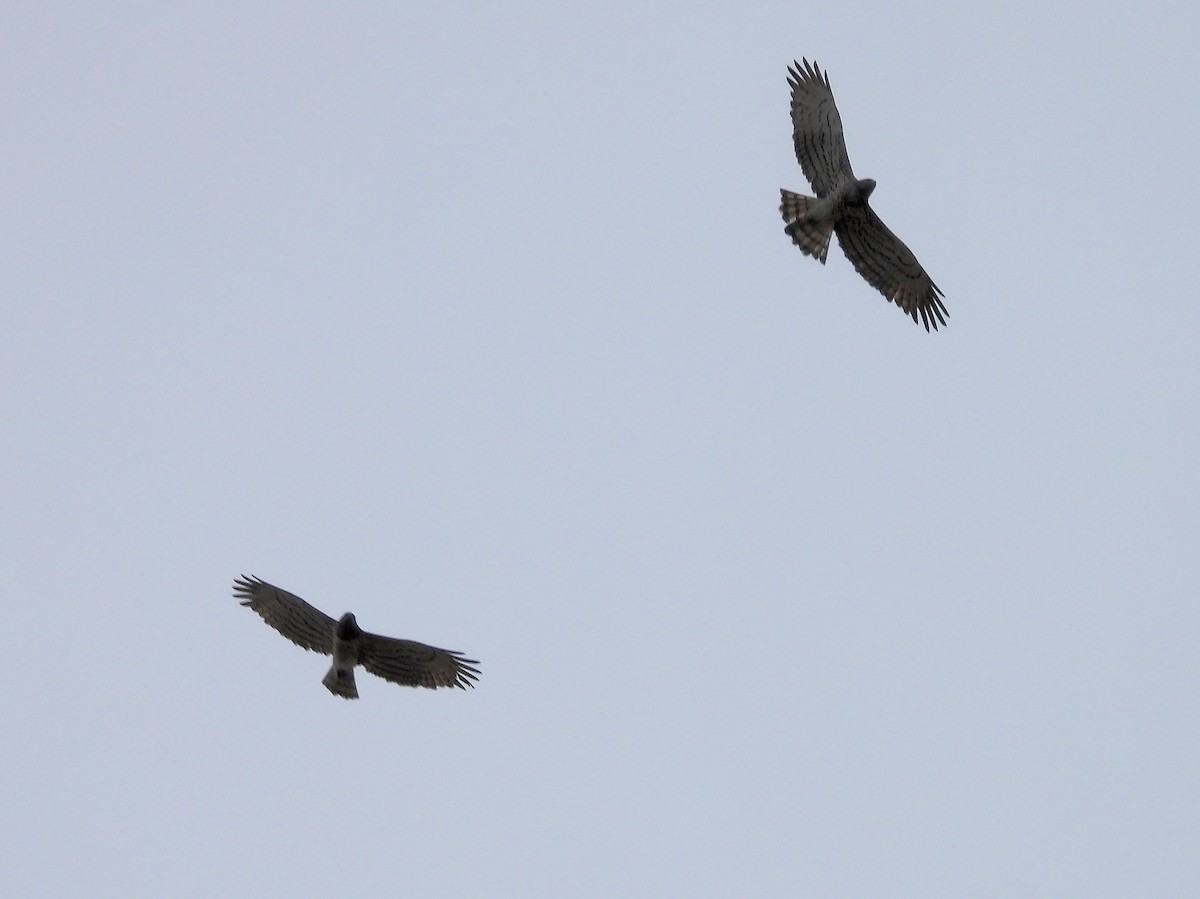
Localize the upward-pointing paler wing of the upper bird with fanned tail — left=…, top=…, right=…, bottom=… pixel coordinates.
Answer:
left=787, top=59, right=854, bottom=197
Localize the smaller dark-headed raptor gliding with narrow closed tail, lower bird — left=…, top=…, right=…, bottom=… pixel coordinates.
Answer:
left=233, top=575, right=479, bottom=700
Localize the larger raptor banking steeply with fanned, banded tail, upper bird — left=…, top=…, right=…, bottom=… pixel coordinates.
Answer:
left=779, top=59, right=949, bottom=331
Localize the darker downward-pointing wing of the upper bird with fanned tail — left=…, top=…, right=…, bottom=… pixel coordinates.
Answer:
left=833, top=205, right=949, bottom=331
